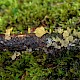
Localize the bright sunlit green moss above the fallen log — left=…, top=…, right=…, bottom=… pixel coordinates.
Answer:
left=0, top=0, right=80, bottom=32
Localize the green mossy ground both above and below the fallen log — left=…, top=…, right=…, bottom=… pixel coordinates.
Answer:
left=0, top=0, right=80, bottom=80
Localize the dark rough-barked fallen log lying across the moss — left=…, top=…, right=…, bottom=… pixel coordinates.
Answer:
left=0, top=33, right=80, bottom=54
